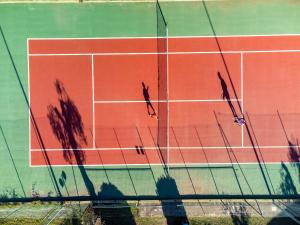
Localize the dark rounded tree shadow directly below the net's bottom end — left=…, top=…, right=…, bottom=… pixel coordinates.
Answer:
left=156, top=174, right=188, bottom=225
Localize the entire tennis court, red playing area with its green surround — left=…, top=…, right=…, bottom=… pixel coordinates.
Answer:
left=0, top=2, right=300, bottom=200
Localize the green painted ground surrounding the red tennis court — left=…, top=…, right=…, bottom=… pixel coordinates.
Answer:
left=0, top=0, right=300, bottom=198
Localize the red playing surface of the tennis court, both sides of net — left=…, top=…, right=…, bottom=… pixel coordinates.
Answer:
left=28, top=35, right=300, bottom=166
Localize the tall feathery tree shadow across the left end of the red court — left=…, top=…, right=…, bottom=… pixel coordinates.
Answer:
left=47, top=80, right=96, bottom=197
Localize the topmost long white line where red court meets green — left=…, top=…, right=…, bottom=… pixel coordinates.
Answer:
left=27, top=34, right=300, bottom=41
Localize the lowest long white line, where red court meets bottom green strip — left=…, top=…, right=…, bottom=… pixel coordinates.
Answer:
left=31, top=162, right=300, bottom=169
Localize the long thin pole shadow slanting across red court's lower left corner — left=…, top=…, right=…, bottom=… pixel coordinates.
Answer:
left=0, top=25, right=62, bottom=197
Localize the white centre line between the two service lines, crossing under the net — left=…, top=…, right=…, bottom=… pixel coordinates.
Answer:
left=94, top=99, right=240, bottom=104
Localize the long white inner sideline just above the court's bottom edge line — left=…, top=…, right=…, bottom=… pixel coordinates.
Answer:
left=30, top=145, right=300, bottom=152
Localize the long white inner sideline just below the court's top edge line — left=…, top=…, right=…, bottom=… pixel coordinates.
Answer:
left=29, top=49, right=300, bottom=57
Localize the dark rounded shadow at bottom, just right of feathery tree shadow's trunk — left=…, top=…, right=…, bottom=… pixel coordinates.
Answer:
left=94, top=183, right=136, bottom=225
